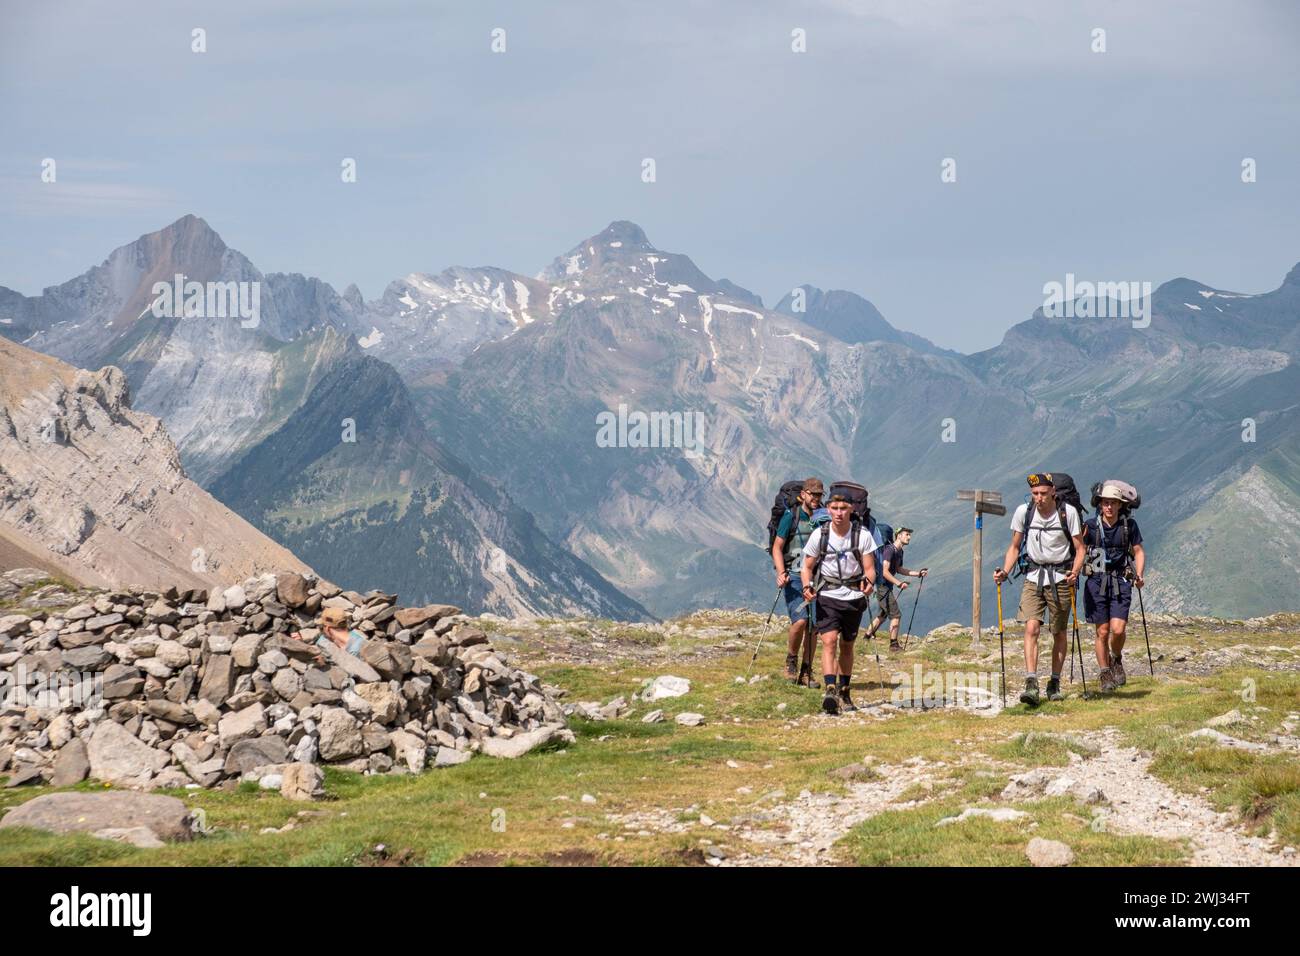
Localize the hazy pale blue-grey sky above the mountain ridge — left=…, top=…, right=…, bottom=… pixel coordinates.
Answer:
left=0, top=0, right=1300, bottom=351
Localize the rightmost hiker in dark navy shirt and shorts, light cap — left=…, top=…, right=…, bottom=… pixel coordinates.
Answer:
left=1083, top=480, right=1147, bottom=693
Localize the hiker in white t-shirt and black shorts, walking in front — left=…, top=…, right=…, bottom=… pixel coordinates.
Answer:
left=800, top=494, right=876, bottom=714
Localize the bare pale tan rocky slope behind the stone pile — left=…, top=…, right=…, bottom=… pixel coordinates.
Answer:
left=0, top=338, right=308, bottom=588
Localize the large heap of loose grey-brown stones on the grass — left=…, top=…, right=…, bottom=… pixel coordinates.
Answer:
left=0, top=572, right=573, bottom=799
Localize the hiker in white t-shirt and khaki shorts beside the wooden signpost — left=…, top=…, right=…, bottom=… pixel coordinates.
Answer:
left=993, top=472, right=1084, bottom=706
